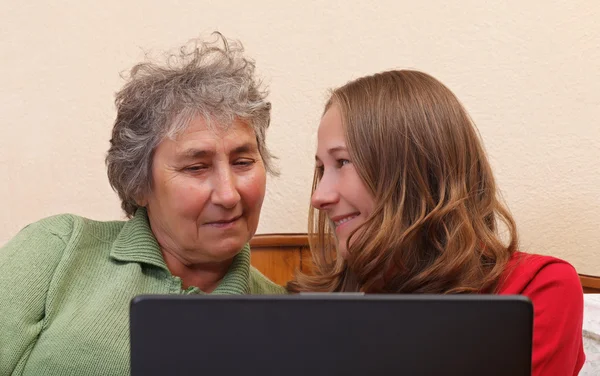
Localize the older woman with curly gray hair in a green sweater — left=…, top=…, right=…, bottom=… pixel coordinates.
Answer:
left=0, top=36, right=283, bottom=376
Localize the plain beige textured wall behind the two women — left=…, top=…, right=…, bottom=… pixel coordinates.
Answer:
left=0, top=0, right=600, bottom=274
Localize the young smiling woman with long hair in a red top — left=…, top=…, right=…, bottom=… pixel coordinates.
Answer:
left=288, top=70, right=584, bottom=376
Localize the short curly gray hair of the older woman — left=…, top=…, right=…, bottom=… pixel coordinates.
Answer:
left=106, top=32, right=278, bottom=218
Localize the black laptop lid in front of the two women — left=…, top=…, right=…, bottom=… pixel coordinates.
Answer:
left=130, top=294, right=533, bottom=376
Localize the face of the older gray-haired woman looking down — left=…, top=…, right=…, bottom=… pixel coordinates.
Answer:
left=145, top=117, right=266, bottom=264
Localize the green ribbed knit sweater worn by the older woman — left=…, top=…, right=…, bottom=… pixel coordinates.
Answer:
left=0, top=210, right=284, bottom=376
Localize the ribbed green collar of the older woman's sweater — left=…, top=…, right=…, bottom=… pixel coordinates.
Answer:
left=110, top=208, right=250, bottom=295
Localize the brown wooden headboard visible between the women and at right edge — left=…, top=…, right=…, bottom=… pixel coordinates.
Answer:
left=250, top=234, right=600, bottom=293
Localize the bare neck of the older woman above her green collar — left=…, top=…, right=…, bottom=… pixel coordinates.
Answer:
left=161, top=249, right=233, bottom=293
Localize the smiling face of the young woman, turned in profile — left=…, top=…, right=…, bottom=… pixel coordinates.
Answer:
left=311, top=105, right=375, bottom=258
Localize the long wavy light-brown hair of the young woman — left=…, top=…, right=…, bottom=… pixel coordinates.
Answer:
left=288, top=70, right=518, bottom=293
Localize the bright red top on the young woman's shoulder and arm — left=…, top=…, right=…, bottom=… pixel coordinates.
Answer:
left=499, top=252, right=585, bottom=376
